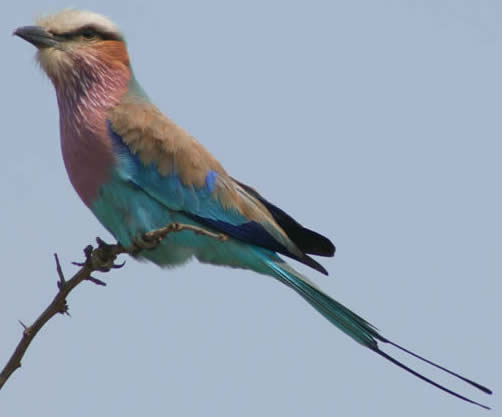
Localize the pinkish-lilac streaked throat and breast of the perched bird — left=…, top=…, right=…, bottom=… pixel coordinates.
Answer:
left=52, top=57, right=130, bottom=206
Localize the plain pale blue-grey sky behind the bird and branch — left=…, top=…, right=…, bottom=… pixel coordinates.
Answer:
left=0, top=0, right=502, bottom=417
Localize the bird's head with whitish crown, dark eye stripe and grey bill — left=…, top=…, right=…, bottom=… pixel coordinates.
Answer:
left=14, top=10, right=130, bottom=87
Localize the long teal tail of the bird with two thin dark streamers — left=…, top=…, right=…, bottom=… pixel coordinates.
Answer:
left=266, top=257, right=492, bottom=409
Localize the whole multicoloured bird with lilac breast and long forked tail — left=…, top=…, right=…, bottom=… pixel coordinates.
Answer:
left=14, top=9, right=492, bottom=408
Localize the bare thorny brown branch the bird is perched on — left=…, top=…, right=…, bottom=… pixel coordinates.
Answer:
left=0, top=223, right=227, bottom=389
